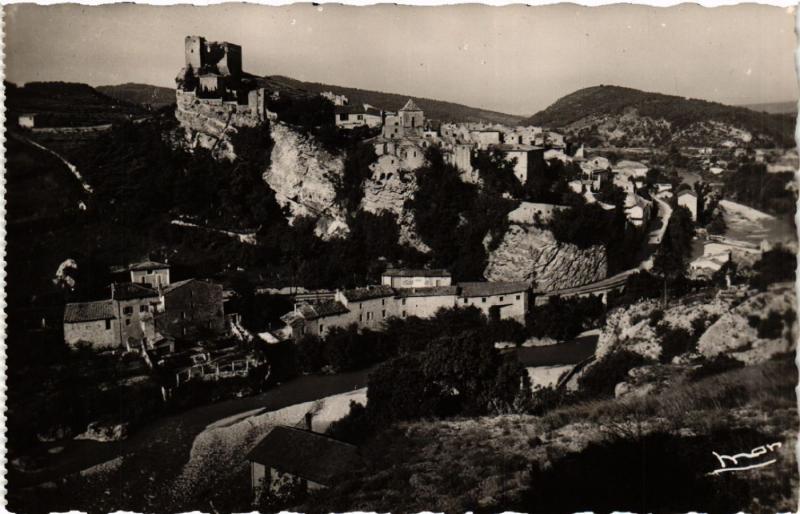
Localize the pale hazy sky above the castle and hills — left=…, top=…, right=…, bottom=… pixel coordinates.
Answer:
left=5, top=4, right=798, bottom=114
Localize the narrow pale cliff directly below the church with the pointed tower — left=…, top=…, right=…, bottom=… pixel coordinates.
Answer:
left=361, top=155, right=431, bottom=253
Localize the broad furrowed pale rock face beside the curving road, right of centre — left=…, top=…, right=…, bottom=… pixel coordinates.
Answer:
left=483, top=224, right=607, bottom=291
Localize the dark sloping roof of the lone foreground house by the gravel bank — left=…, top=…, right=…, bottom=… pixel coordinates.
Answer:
left=247, top=426, right=361, bottom=486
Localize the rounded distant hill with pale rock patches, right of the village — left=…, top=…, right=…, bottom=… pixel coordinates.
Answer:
left=526, top=86, right=794, bottom=147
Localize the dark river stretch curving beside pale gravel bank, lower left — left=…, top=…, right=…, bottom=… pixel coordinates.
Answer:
left=8, top=368, right=372, bottom=513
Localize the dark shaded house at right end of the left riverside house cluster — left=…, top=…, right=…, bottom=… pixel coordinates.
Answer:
left=156, top=278, right=226, bottom=338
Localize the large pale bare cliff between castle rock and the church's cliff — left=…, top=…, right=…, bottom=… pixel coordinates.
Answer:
left=264, top=122, right=349, bottom=240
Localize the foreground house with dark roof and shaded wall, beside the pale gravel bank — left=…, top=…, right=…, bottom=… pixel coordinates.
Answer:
left=247, top=426, right=361, bottom=498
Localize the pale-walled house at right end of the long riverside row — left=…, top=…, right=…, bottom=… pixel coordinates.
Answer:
left=458, top=282, right=531, bottom=323
